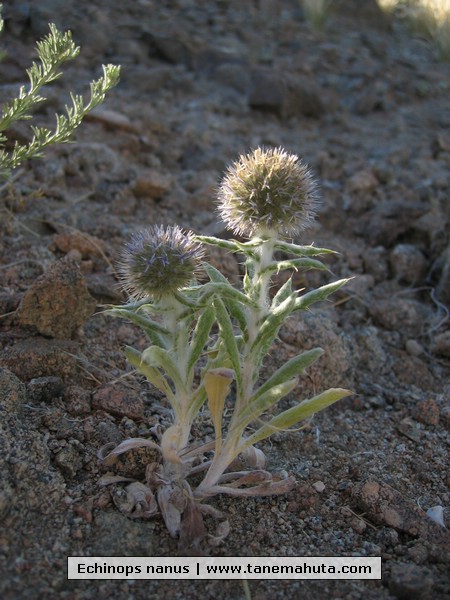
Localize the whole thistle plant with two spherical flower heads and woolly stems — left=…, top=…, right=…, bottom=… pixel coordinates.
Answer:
left=100, top=148, right=350, bottom=544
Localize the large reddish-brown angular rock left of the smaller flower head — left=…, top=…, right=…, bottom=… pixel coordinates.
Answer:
left=18, top=258, right=96, bottom=339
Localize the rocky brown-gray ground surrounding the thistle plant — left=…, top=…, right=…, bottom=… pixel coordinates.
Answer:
left=0, top=0, right=450, bottom=600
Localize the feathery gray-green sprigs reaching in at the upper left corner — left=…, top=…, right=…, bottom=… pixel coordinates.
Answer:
left=0, top=5, right=120, bottom=177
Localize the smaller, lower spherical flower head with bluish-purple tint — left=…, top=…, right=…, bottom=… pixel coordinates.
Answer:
left=119, top=225, right=203, bottom=300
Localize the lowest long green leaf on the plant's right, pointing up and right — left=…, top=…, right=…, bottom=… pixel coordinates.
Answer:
left=240, top=388, right=353, bottom=452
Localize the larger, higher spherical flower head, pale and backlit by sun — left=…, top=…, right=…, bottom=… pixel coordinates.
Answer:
left=218, top=148, right=318, bottom=237
